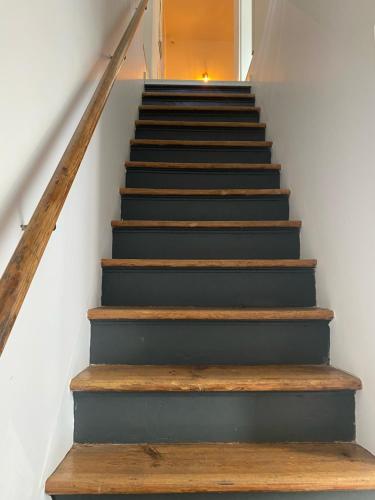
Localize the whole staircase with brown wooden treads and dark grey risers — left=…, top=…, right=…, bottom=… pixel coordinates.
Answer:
left=46, top=83, right=375, bottom=500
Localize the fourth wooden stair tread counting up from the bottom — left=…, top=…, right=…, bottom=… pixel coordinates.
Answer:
left=102, top=259, right=317, bottom=269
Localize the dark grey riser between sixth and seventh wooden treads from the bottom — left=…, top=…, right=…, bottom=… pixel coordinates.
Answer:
left=126, top=167, right=280, bottom=189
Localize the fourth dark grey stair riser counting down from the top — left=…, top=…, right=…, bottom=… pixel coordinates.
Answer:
left=135, top=125, right=266, bottom=141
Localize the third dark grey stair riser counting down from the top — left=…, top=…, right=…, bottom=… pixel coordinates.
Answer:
left=139, top=109, right=259, bottom=122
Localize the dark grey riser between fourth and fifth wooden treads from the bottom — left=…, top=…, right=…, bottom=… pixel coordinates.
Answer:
left=112, top=228, right=300, bottom=259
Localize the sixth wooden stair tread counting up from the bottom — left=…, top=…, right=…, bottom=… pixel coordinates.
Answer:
left=120, top=187, right=290, bottom=196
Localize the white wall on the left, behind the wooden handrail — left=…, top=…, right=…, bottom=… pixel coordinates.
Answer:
left=0, top=0, right=145, bottom=500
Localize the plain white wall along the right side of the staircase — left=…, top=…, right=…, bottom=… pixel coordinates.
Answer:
left=253, top=0, right=375, bottom=452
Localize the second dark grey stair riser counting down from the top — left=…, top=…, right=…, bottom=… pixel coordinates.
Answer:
left=142, top=94, right=255, bottom=106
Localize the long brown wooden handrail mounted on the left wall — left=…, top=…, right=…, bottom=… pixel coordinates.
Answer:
left=0, top=0, right=147, bottom=354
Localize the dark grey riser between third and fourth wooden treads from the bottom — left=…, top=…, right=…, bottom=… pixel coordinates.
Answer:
left=102, top=268, right=315, bottom=307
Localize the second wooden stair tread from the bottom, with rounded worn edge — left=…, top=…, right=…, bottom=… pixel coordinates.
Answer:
left=70, top=365, right=361, bottom=392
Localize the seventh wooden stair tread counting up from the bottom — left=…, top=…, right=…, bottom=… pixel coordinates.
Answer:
left=125, top=161, right=281, bottom=170
